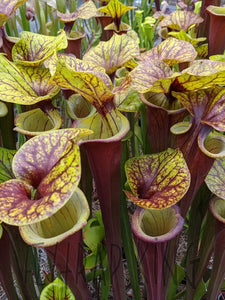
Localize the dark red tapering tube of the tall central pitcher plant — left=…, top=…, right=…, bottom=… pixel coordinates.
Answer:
left=83, top=139, right=126, bottom=300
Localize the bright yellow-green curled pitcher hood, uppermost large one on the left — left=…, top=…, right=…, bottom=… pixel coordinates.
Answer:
left=12, top=31, right=67, bottom=67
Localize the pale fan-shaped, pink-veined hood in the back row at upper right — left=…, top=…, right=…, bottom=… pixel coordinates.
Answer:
left=159, top=10, right=203, bottom=32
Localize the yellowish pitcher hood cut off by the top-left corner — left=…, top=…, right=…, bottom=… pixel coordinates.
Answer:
left=0, top=0, right=27, bottom=26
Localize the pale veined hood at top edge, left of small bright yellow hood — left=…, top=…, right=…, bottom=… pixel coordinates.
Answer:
left=57, top=0, right=97, bottom=23
